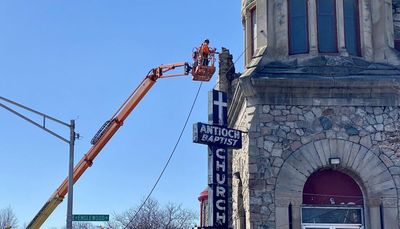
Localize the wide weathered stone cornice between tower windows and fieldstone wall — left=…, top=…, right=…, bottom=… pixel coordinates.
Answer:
left=229, top=57, right=400, bottom=121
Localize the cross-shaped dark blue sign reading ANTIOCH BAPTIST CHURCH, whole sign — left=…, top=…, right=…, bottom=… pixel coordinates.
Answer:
left=193, top=90, right=242, bottom=229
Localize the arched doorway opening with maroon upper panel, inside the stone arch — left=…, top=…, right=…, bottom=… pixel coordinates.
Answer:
left=301, top=169, right=364, bottom=229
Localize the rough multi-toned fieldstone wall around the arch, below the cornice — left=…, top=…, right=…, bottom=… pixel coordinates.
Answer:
left=232, top=105, right=400, bottom=229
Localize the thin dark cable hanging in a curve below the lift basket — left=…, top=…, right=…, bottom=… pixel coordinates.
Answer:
left=124, top=82, right=203, bottom=229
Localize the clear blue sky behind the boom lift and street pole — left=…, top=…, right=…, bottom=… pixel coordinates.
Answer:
left=0, top=0, right=243, bottom=228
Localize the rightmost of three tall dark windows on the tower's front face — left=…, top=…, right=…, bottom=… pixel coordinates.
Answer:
left=343, top=0, right=361, bottom=56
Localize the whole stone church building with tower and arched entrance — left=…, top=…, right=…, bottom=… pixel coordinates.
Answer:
left=217, top=0, right=400, bottom=229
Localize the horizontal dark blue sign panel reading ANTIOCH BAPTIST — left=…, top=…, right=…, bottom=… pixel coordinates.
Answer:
left=193, top=122, right=242, bottom=149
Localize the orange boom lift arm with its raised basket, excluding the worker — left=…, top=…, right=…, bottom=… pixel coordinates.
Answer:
left=27, top=51, right=215, bottom=229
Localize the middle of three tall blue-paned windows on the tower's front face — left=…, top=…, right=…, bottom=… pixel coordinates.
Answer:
left=317, top=0, right=338, bottom=53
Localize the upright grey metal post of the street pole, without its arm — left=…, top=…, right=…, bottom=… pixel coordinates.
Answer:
left=67, top=120, right=75, bottom=229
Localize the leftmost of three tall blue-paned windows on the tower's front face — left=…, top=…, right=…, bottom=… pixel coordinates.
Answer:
left=288, top=0, right=308, bottom=54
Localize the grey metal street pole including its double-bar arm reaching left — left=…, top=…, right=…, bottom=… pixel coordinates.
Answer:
left=0, top=96, right=79, bottom=229
